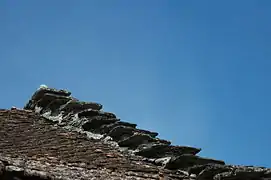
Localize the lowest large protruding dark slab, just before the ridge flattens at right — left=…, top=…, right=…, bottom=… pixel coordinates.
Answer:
left=166, top=154, right=225, bottom=169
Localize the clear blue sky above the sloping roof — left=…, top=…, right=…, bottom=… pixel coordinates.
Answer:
left=0, top=0, right=271, bottom=167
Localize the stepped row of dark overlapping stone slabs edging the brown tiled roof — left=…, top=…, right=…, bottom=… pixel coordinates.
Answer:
left=0, top=87, right=271, bottom=180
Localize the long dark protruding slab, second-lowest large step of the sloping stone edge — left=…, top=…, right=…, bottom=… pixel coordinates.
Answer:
left=136, top=144, right=201, bottom=158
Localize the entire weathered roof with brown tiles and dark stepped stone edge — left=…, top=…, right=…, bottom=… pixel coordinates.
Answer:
left=0, top=86, right=271, bottom=180
